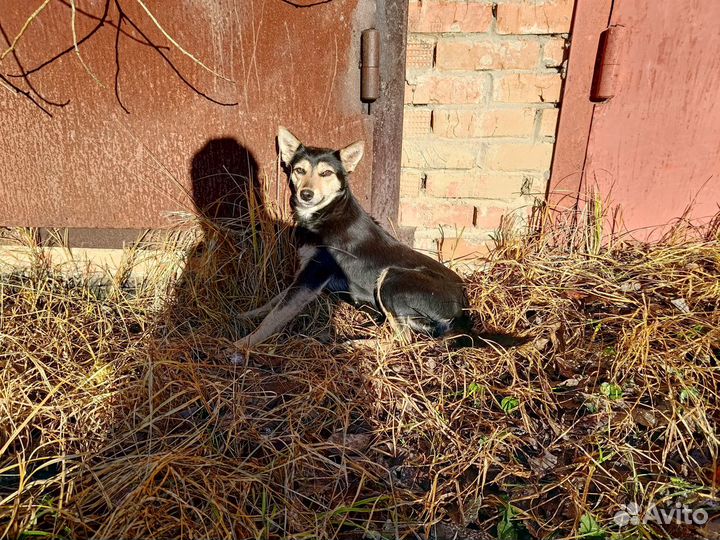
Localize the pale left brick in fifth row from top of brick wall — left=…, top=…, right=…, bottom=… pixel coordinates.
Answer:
left=402, top=139, right=481, bottom=169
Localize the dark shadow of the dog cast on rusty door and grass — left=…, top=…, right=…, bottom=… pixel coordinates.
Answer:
left=171, top=137, right=292, bottom=342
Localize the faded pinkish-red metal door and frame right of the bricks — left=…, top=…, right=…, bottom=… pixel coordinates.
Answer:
left=551, top=0, right=720, bottom=240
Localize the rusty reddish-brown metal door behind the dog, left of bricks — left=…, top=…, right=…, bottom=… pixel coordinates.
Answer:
left=0, top=0, right=406, bottom=236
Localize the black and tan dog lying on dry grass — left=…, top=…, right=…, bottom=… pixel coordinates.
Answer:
left=234, top=127, right=472, bottom=360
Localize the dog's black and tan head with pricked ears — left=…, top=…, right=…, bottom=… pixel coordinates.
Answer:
left=278, top=126, right=365, bottom=218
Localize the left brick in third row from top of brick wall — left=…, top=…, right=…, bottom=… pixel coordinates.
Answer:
left=412, top=75, right=490, bottom=105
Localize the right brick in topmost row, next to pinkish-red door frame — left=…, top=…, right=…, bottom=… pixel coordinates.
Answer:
left=496, top=0, right=575, bottom=34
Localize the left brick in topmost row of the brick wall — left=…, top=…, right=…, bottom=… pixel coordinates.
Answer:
left=408, top=0, right=493, bottom=32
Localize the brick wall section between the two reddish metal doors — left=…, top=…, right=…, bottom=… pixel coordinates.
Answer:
left=400, top=0, right=574, bottom=260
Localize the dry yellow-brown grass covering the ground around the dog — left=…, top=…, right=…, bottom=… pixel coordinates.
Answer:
left=0, top=208, right=720, bottom=540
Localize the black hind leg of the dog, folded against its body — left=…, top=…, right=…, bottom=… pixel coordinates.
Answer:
left=375, top=267, right=466, bottom=337
